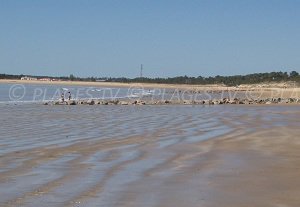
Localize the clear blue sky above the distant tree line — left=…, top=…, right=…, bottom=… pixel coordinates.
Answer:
left=0, top=0, right=300, bottom=77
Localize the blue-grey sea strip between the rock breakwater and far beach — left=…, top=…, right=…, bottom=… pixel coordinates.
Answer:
left=0, top=83, right=253, bottom=104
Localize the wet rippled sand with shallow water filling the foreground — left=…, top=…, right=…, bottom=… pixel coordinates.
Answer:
left=0, top=105, right=300, bottom=207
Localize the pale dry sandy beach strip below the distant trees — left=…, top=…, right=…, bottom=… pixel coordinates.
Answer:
left=0, top=79, right=300, bottom=99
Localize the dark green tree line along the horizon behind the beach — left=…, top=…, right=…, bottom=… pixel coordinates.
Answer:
left=0, top=71, right=300, bottom=86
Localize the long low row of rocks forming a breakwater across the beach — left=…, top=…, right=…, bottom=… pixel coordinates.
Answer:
left=44, top=98, right=300, bottom=105
